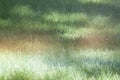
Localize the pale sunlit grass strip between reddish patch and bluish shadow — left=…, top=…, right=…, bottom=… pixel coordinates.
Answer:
left=73, top=49, right=117, bottom=60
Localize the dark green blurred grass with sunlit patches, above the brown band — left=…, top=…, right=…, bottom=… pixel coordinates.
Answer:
left=0, top=0, right=120, bottom=35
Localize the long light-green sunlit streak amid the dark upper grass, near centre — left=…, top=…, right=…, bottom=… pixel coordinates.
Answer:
left=44, top=12, right=87, bottom=23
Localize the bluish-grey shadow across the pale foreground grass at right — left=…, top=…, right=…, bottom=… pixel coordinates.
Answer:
left=47, top=53, right=120, bottom=77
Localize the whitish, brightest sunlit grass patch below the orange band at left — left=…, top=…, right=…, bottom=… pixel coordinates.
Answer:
left=0, top=52, right=48, bottom=75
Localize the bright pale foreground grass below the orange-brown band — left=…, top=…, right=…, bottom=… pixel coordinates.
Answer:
left=0, top=49, right=120, bottom=80
